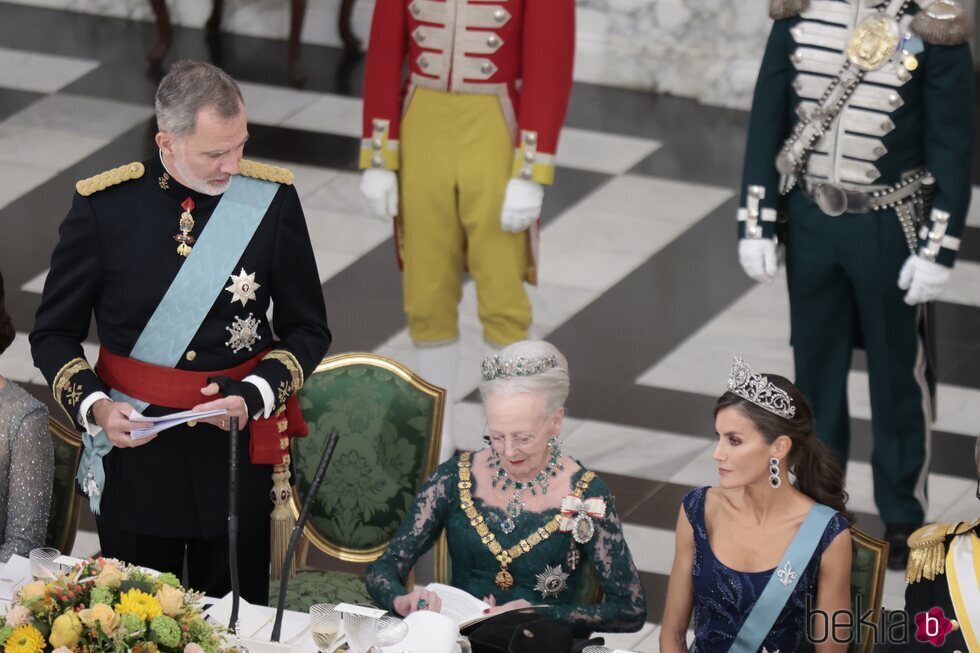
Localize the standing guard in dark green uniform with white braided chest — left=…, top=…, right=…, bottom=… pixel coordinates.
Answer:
left=738, top=0, right=974, bottom=568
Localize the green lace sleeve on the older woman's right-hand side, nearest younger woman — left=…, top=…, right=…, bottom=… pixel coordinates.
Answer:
left=552, top=478, right=647, bottom=632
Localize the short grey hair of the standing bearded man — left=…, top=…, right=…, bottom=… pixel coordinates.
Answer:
left=156, top=60, right=245, bottom=136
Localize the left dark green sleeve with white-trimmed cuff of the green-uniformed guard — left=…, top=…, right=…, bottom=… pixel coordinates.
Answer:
left=738, top=17, right=799, bottom=238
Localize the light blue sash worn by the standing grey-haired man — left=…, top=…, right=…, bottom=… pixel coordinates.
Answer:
left=78, top=175, right=279, bottom=514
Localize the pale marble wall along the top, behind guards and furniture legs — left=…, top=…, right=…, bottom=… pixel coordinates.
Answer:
left=13, top=0, right=975, bottom=108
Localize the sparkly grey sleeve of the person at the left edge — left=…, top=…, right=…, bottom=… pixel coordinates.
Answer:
left=0, top=407, right=54, bottom=561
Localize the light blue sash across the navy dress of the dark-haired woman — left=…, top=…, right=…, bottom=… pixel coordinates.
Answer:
left=728, top=503, right=836, bottom=653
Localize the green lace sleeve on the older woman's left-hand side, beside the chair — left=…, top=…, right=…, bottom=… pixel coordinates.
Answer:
left=365, top=457, right=456, bottom=611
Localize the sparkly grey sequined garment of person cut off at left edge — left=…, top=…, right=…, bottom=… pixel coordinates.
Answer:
left=0, top=381, right=54, bottom=562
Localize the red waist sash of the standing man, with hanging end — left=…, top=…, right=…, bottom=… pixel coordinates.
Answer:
left=95, top=347, right=308, bottom=465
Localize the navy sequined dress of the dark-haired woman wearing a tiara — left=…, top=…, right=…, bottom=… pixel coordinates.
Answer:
left=683, top=487, right=848, bottom=653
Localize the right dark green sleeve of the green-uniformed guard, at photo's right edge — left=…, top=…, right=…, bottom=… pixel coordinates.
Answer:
left=919, top=43, right=974, bottom=267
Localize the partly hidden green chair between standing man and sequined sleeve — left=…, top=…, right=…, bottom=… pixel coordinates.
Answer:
left=45, top=417, right=82, bottom=555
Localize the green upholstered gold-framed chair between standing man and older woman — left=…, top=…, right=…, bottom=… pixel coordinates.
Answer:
left=273, top=353, right=445, bottom=612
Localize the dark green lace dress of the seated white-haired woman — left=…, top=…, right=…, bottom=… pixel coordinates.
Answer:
left=367, top=457, right=647, bottom=633
